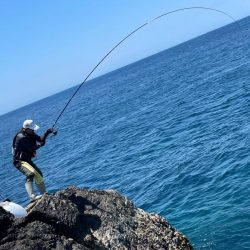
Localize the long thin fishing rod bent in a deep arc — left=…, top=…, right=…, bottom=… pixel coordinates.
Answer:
left=52, top=6, right=236, bottom=129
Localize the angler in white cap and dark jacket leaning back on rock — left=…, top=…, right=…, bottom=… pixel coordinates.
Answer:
left=12, top=120, right=53, bottom=202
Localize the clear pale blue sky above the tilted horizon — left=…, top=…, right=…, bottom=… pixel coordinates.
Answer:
left=0, top=0, right=250, bottom=114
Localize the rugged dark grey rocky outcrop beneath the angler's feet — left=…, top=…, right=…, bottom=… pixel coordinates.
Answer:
left=0, top=187, right=192, bottom=250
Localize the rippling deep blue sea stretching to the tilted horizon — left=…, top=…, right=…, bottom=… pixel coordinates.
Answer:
left=0, top=18, right=250, bottom=250
